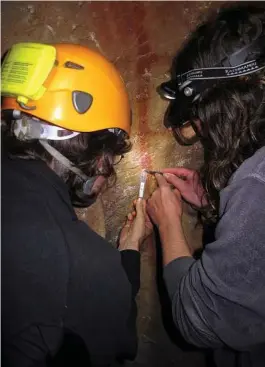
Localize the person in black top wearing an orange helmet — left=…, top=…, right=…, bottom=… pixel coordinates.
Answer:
left=1, top=43, right=152, bottom=367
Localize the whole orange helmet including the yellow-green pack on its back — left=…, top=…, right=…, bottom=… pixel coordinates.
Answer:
left=1, top=43, right=131, bottom=134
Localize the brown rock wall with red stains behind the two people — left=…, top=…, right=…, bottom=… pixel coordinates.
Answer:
left=2, top=1, right=223, bottom=367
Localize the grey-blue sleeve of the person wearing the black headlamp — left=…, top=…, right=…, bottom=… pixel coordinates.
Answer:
left=164, top=177, right=265, bottom=350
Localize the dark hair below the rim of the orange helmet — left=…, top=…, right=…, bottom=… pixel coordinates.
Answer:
left=2, top=115, right=131, bottom=207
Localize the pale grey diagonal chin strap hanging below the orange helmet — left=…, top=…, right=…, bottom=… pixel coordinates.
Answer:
left=39, top=139, right=97, bottom=195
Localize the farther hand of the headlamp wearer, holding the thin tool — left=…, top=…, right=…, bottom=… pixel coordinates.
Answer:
left=161, top=167, right=208, bottom=208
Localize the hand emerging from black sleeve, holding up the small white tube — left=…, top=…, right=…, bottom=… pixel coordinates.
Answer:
left=118, top=199, right=153, bottom=251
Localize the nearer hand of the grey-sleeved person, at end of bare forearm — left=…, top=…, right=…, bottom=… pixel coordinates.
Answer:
left=147, top=174, right=182, bottom=227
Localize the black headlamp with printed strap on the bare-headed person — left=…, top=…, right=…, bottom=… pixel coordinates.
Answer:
left=158, top=37, right=265, bottom=144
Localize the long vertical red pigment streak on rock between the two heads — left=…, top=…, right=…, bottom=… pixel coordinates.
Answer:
left=110, top=2, right=158, bottom=168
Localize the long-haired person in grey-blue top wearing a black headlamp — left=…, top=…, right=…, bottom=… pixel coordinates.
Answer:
left=147, top=4, right=265, bottom=367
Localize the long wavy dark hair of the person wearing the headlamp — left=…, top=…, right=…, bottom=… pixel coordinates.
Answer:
left=171, top=4, right=265, bottom=220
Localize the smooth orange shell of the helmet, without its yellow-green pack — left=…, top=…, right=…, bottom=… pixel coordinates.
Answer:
left=2, top=43, right=131, bottom=134
